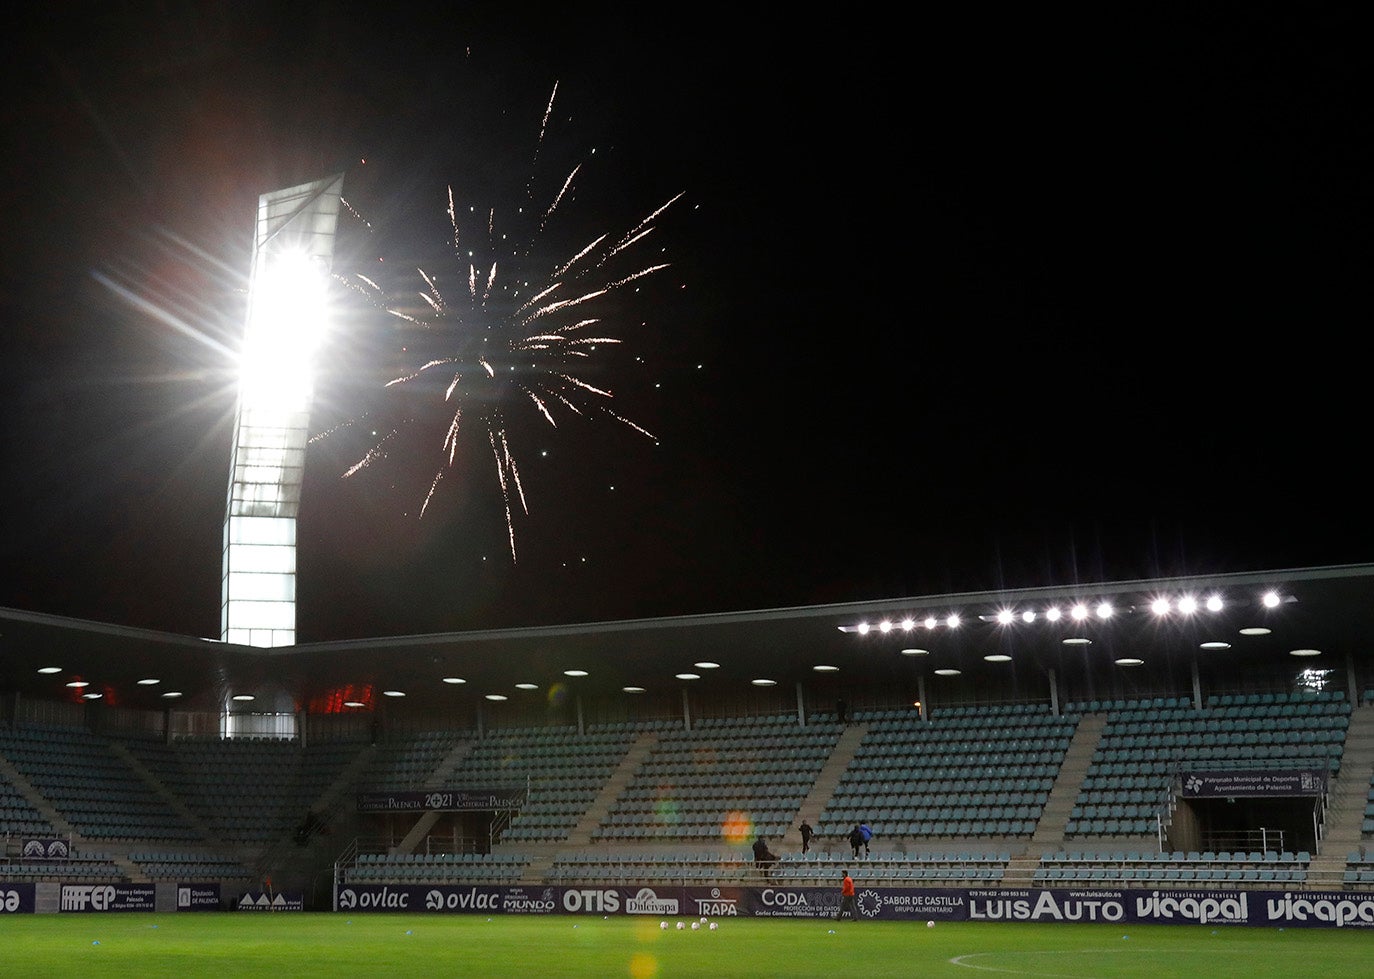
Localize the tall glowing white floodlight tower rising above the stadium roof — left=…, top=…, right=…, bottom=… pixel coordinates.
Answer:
left=220, top=174, right=344, bottom=647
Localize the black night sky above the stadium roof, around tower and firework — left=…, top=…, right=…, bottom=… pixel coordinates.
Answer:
left=0, top=9, right=1374, bottom=641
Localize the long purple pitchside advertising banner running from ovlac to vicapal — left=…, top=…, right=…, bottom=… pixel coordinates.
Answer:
left=335, top=884, right=1374, bottom=928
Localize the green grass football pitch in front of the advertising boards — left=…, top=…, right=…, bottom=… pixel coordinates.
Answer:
left=0, top=912, right=1374, bottom=979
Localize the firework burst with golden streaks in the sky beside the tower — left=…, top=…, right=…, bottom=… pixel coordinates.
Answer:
left=320, top=85, right=683, bottom=560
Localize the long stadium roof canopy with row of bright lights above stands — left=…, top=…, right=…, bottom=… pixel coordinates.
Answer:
left=0, top=564, right=1374, bottom=717
